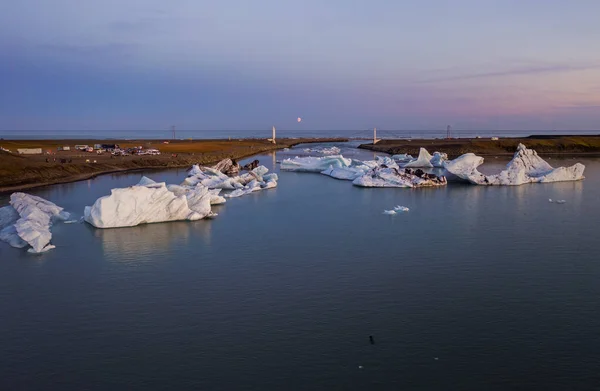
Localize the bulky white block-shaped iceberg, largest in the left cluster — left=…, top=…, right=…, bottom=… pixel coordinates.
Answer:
left=84, top=178, right=212, bottom=228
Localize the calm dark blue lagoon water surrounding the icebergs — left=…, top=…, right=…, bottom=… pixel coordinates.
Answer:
left=0, top=148, right=600, bottom=390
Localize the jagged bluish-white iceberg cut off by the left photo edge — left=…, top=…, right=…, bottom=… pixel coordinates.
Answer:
left=0, top=193, right=69, bottom=253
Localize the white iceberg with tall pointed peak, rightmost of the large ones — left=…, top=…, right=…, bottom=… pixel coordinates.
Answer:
left=444, top=144, right=585, bottom=186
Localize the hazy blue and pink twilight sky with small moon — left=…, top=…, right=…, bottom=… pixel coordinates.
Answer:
left=0, top=0, right=600, bottom=131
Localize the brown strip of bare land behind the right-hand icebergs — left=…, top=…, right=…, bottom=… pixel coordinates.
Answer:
left=359, top=135, right=600, bottom=158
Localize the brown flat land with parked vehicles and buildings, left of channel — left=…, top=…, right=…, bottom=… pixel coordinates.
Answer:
left=0, top=138, right=347, bottom=192
